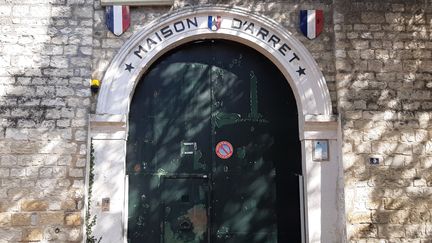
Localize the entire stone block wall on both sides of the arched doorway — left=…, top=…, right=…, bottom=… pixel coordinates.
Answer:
left=0, top=0, right=432, bottom=242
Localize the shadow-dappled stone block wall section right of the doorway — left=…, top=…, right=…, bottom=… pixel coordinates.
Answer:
left=334, top=1, right=432, bottom=242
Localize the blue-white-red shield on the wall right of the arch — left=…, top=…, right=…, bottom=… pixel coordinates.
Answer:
left=300, top=10, right=324, bottom=40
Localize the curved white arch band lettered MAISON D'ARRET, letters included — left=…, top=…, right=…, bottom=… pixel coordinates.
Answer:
left=97, top=6, right=332, bottom=116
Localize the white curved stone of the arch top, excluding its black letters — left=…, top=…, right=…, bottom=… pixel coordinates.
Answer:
left=97, top=6, right=332, bottom=116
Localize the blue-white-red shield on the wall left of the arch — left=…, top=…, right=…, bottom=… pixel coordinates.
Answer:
left=105, top=5, right=130, bottom=36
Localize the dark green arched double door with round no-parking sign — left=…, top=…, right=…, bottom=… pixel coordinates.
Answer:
left=126, top=40, right=303, bottom=243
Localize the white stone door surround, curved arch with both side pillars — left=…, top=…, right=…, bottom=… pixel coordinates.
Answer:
left=90, top=6, right=344, bottom=242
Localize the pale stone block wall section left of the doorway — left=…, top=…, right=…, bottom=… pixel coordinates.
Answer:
left=0, top=0, right=93, bottom=242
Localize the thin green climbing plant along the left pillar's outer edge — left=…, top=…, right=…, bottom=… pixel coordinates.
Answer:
left=85, top=141, right=102, bottom=243
